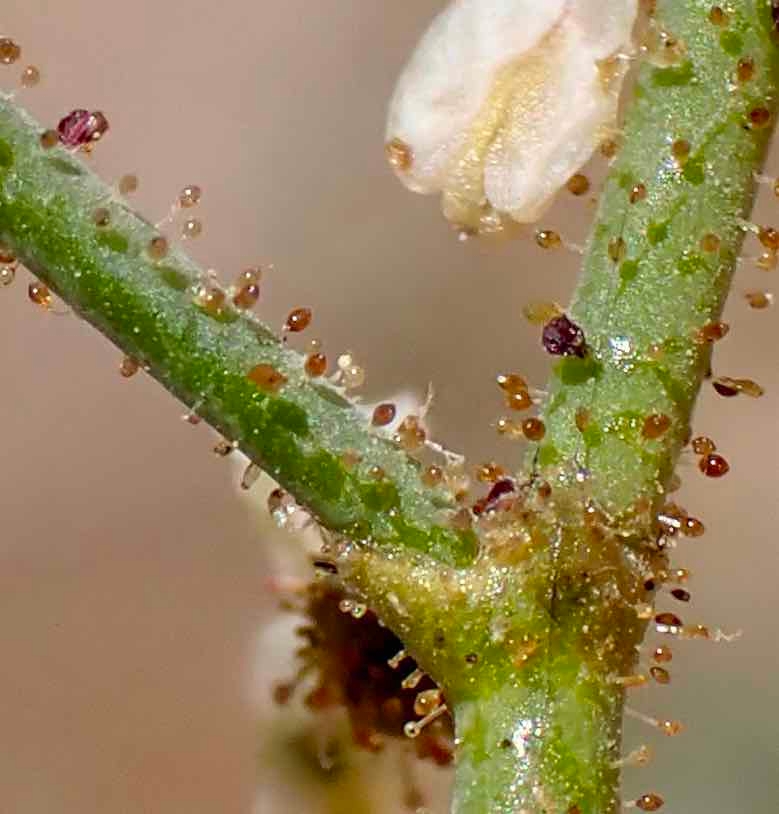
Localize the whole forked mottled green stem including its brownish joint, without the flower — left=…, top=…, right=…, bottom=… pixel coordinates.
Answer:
left=0, top=0, right=777, bottom=814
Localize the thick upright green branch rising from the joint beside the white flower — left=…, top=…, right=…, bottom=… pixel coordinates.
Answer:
left=537, top=0, right=779, bottom=514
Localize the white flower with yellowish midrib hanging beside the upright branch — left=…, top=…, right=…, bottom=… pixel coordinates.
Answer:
left=387, top=0, right=638, bottom=232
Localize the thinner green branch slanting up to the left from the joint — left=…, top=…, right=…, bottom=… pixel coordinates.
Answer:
left=0, top=96, right=475, bottom=562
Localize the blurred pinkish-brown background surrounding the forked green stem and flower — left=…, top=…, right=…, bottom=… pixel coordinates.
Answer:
left=0, top=0, right=779, bottom=814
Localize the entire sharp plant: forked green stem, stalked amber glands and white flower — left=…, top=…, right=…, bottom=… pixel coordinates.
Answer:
left=0, top=0, right=779, bottom=814
